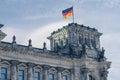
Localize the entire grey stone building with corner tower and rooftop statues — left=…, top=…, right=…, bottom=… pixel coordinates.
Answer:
left=0, top=23, right=111, bottom=80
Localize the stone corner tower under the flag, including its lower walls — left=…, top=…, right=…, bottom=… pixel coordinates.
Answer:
left=48, top=23, right=111, bottom=80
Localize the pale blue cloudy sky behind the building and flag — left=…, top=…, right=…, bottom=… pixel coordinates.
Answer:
left=0, top=0, right=120, bottom=80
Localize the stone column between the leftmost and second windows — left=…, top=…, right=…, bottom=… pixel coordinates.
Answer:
left=11, top=60, right=19, bottom=80
